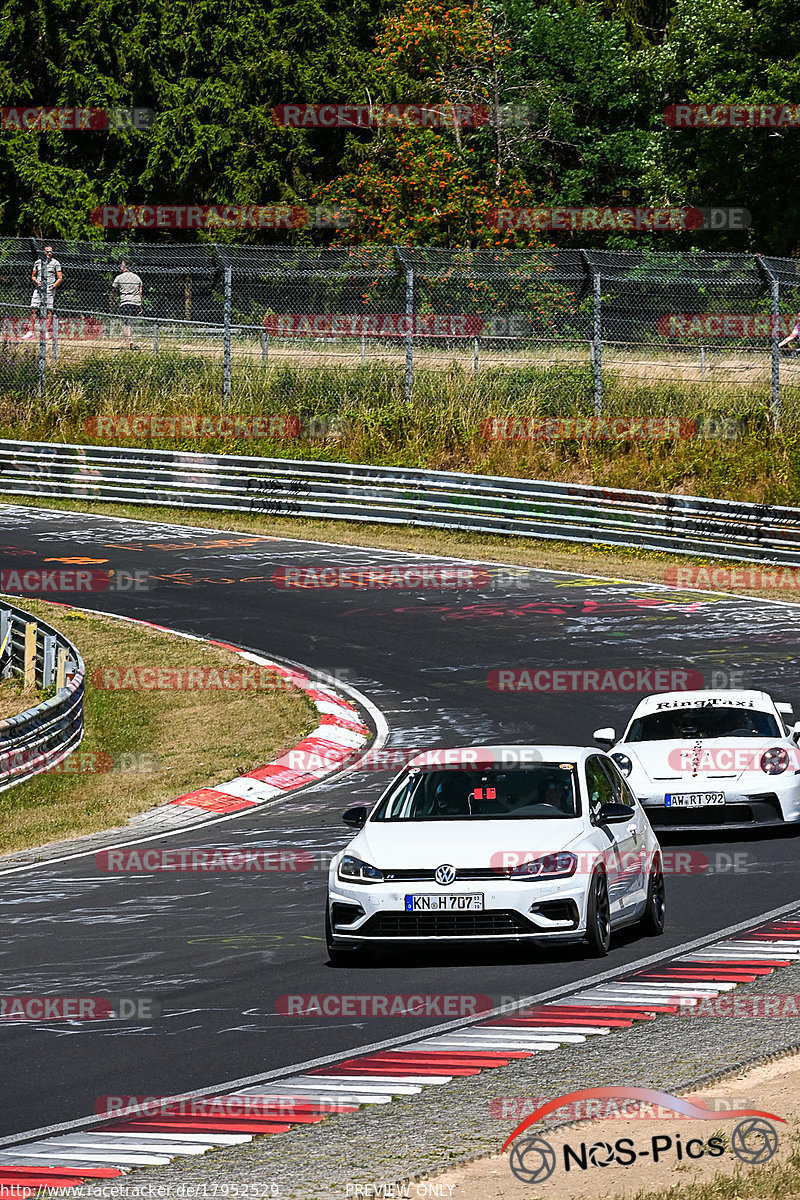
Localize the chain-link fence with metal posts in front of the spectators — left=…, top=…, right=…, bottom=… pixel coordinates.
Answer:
left=0, top=239, right=800, bottom=421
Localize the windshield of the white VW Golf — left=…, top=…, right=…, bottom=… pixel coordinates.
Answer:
left=372, top=763, right=581, bottom=821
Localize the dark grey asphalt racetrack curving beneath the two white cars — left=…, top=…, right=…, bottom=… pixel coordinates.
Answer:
left=0, top=508, right=800, bottom=1136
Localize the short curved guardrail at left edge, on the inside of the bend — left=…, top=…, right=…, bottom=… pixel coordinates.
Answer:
left=0, top=600, right=85, bottom=791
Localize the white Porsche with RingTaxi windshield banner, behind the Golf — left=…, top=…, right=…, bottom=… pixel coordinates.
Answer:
left=594, top=691, right=800, bottom=829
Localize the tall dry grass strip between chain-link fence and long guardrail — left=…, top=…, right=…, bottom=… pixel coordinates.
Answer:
left=0, top=353, right=800, bottom=505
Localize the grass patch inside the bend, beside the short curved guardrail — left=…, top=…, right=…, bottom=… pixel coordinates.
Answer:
left=0, top=599, right=318, bottom=853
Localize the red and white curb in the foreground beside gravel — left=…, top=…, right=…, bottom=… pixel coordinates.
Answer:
left=0, top=916, right=800, bottom=1180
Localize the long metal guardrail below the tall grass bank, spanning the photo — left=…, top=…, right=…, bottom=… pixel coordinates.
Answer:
left=0, top=440, right=800, bottom=565
